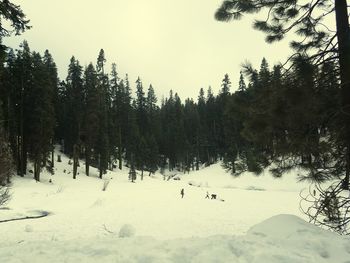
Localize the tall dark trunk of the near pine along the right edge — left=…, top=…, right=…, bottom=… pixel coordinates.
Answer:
left=334, top=0, right=350, bottom=189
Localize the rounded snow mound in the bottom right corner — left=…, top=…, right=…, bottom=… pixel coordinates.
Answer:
left=247, top=215, right=349, bottom=262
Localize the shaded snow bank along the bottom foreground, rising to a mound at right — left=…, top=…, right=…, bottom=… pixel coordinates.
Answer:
left=0, top=215, right=350, bottom=263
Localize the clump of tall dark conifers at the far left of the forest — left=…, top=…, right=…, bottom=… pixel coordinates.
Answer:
left=3, top=42, right=57, bottom=181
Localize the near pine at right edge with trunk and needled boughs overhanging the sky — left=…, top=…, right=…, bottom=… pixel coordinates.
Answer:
left=215, top=0, right=350, bottom=189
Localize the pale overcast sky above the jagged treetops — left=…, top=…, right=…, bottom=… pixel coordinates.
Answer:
left=4, top=0, right=296, bottom=100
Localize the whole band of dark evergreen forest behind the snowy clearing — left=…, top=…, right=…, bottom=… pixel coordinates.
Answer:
left=0, top=42, right=345, bottom=186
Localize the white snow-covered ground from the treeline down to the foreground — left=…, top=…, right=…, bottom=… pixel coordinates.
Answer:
left=0, top=152, right=350, bottom=263
